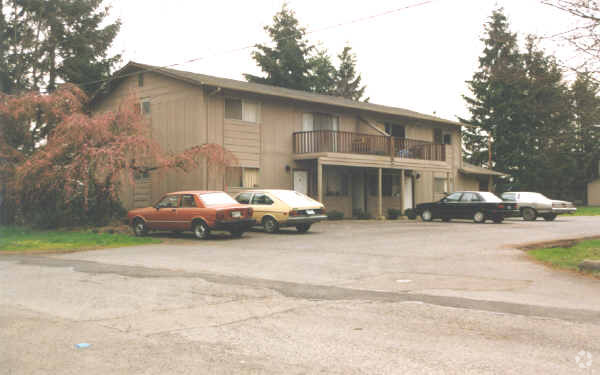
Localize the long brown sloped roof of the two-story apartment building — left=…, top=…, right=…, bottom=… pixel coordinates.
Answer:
left=99, top=61, right=468, bottom=126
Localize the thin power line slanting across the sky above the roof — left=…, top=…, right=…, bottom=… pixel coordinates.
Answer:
left=41, top=0, right=439, bottom=93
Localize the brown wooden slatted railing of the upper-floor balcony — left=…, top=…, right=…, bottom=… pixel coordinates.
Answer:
left=294, top=130, right=446, bottom=161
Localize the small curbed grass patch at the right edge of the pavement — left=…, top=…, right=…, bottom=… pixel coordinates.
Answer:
left=529, top=240, right=600, bottom=274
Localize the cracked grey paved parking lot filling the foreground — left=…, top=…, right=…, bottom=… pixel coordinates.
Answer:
left=0, top=217, right=600, bottom=374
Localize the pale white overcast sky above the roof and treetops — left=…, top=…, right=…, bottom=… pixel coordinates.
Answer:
left=108, top=0, right=574, bottom=120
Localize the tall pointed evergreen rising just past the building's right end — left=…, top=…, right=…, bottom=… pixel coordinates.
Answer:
left=461, top=9, right=530, bottom=191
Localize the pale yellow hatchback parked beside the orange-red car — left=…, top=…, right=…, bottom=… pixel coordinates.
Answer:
left=235, top=190, right=327, bottom=233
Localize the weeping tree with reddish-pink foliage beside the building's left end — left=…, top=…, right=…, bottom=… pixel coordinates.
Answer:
left=0, top=85, right=237, bottom=226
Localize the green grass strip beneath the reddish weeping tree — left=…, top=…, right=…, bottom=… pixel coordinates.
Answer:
left=0, top=227, right=161, bottom=252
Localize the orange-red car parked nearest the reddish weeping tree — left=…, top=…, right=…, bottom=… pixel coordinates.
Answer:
left=127, top=191, right=256, bottom=239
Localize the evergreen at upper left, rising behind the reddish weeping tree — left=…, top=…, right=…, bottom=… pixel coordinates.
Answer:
left=0, top=0, right=120, bottom=93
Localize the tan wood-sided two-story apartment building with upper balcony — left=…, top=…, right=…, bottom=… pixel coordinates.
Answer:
left=92, top=62, right=502, bottom=217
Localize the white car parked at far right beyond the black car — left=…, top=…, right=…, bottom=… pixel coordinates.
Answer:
left=502, top=191, right=577, bottom=221
